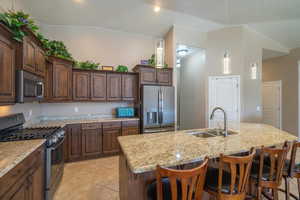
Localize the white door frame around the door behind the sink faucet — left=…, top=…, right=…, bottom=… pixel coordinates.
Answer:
left=206, top=75, right=241, bottom=127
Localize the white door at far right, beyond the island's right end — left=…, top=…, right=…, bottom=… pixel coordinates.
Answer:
left=263, top=81, right=281, bottom=129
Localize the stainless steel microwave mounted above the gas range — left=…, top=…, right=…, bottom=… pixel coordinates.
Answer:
left=16, top=70, right=44, bottom=103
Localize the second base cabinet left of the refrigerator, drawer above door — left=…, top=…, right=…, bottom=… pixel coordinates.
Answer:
left=103, top=122, right=122, bottom=153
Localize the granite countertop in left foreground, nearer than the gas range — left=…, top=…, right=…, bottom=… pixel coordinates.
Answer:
left=0, top=139, right=46, bottom=178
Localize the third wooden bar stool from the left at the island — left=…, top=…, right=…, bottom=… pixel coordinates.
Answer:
left=251, top=142, right=290, bottom=200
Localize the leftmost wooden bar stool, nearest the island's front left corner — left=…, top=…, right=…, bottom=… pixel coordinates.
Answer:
left=147, top=158, right=208, bottom=200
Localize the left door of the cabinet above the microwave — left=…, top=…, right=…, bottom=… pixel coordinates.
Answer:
left=23, top=37, right=36, bottom=73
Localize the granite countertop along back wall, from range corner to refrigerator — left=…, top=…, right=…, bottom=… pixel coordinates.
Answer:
left=25, top=118, right=139, bottom=128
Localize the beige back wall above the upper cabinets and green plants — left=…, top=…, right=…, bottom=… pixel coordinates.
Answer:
left=41, top=25, right=157, bottom=68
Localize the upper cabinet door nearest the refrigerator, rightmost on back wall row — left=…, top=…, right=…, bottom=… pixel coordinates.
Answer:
left=122, top=74, right=138, bottom=101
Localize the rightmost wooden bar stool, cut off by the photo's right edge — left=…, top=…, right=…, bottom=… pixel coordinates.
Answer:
left=280, top=141, right=300, bottom=200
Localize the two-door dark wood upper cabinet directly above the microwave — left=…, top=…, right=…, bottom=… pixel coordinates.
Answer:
left=16, top=27, right=46, bottom=77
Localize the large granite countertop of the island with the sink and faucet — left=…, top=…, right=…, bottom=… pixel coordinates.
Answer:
left=118, top=123, right=297, bottom=173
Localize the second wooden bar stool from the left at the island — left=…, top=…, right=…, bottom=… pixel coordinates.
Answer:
left=205, top=148, right=255, bottom=200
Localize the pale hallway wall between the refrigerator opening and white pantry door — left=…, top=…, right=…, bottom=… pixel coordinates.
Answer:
left=178, top=49, right=206, bottom=130
